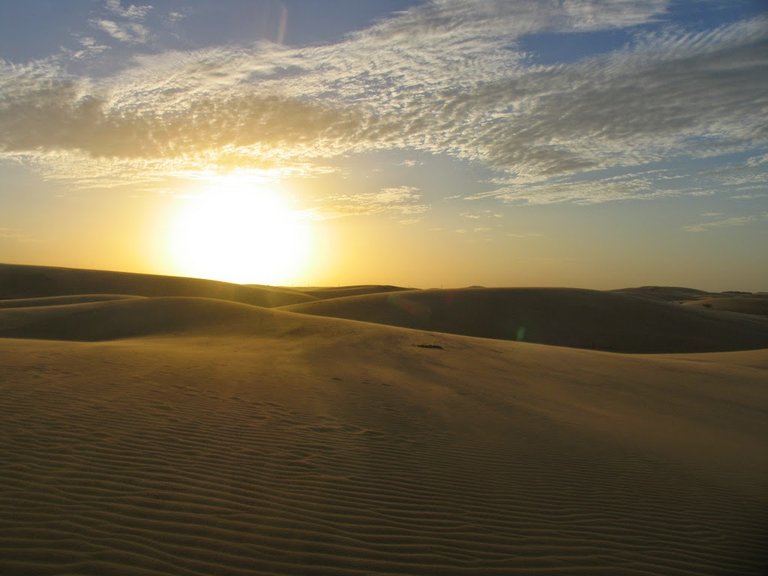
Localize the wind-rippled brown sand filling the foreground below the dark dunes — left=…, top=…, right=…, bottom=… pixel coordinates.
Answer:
left=0, top=299, right=768, bottom=576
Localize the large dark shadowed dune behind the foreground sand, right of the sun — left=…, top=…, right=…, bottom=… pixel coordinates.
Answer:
left=285, top=288, right=768, bottom=352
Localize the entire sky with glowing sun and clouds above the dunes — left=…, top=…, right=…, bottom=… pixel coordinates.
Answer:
left=0, top=0, right=768, bottom=291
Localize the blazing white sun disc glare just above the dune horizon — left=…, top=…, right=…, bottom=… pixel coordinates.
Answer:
left=169, top=176, right=312, bottom=285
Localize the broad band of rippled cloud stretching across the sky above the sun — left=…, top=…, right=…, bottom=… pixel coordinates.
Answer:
left=0, top=0, right=768, bottom=203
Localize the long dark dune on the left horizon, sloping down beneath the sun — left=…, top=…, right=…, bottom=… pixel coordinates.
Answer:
left=0, top=264, right=313, bottom=307
